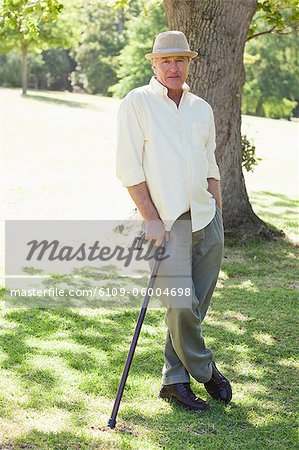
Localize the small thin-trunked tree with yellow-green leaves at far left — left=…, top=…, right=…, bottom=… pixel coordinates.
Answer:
left=0, top=0, right=77, bottom=94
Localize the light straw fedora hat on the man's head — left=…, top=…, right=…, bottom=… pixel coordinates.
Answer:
left=145, top=30, right=198, bottom=59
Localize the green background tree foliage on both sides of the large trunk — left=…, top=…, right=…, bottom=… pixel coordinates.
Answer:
left=0, top=0, right=299, bottom=117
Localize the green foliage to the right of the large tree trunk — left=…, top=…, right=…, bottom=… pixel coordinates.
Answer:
left=246, top=0, right=299, bottom=118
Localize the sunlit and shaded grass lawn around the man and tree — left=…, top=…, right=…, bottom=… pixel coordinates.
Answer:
left=0, top=90, right=299, bottom=450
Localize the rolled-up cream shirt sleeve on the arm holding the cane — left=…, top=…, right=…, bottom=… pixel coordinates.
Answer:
left=116, top=94, right=145, bottom=187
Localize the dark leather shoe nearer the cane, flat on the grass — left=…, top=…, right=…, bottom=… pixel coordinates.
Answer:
left=159, top=383, right=209, bottom=411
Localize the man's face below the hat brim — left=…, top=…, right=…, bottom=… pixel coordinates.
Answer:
left=152, top=56, right=190, bottom=90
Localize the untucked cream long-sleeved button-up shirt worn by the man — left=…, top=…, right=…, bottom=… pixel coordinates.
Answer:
left=116, top=77, right=220, bottom=231
